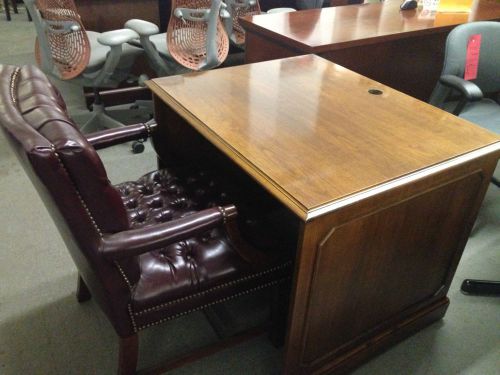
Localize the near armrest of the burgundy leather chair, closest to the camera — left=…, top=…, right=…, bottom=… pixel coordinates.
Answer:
left=100, top=205, right=236, bottom=260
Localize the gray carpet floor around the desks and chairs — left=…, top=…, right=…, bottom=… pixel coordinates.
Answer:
left=0, top=10, right=500, bottom=375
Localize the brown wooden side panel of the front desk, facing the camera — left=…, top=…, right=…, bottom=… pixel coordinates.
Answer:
left=285, top=166, right=488, bottom=374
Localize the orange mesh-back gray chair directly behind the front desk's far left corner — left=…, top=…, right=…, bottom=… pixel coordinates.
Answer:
left=125, top=0, right=229, bottom=76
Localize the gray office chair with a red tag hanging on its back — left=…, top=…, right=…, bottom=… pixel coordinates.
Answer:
left=429, top=21, right=500, bottom=295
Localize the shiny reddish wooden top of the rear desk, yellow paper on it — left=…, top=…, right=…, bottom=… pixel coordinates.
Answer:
left=241, top=0, right=500, bottom=53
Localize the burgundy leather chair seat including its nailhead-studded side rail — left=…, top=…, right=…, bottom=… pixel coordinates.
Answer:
left=116, top=169, right=289, bottom=329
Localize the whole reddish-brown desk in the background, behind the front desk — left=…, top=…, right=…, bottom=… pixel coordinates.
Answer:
left=241, top=0, right=500, bottom=101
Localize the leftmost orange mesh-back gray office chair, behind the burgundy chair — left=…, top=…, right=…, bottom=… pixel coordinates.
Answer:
left=24, top=0, right=143, bottom=137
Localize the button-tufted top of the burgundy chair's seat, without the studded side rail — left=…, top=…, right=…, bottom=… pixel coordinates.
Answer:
left=116, top=169, right=247, bottom=309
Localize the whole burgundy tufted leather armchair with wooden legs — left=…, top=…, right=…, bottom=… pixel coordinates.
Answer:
left=0, top=65, right=290, bottom=374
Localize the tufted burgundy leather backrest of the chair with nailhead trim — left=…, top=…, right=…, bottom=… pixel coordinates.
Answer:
left=0, top=65, right=138, bottom=332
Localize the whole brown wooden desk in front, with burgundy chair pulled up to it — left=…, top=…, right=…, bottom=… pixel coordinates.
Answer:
left=148, top=55, right=500, bottom=374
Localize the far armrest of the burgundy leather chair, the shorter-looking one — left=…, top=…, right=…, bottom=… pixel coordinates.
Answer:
left=85, top=120, right=157, bottom=150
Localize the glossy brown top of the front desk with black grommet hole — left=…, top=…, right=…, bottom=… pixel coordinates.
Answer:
left=148, top=55, right=500, bottom=219
